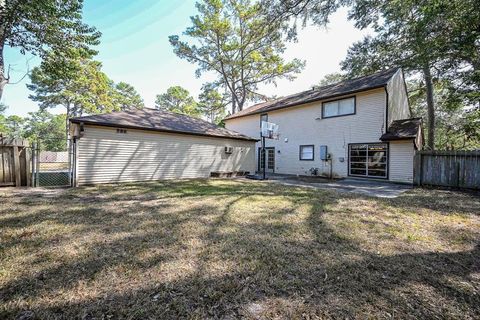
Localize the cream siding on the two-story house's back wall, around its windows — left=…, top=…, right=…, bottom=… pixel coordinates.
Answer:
left=226, top=88, right=388, bottom=177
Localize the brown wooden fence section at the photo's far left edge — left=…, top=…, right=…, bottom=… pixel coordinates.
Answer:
left=0, top=136, right=31, bottom=187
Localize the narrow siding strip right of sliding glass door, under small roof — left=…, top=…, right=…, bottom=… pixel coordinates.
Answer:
left=389, top=140, right=415, bottom=183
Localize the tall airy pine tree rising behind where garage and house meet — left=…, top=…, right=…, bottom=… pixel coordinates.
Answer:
left=170, top=0, right=304, bottom=113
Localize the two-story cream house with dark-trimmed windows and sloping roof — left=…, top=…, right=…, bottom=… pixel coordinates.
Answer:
left=225, top=69, right=423, bottom=183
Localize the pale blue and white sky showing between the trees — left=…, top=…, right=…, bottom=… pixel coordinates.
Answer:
left=2, top=0, right=367, bottom=116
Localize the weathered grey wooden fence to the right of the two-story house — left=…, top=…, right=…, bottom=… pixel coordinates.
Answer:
left=414, top=151, right=480, bottom=189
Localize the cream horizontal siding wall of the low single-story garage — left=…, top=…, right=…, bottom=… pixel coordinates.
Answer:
left=77, top=126, right=255, bottom=185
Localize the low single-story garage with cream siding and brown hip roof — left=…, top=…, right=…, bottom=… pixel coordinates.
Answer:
left=70, top=108, right=256, bottom=185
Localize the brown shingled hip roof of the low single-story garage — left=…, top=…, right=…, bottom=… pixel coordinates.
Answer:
left=70, top=108, right=257, bottom=141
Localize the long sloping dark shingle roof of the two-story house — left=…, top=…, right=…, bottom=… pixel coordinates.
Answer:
left=226, top=69, right=399, bottom=119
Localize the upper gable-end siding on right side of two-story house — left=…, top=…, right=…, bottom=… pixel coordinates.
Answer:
left=387, top=69, right=411, bottom=125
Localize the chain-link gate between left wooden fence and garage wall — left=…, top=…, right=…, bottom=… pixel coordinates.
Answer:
left=32, top=138, right=75, bottom=187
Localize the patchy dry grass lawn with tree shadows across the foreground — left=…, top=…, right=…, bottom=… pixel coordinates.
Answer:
left=0, top=180, right=480, bottom=319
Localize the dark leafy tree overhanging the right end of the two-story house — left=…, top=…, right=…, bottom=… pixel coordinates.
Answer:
left=263, top=0, right=480, bottom=149
